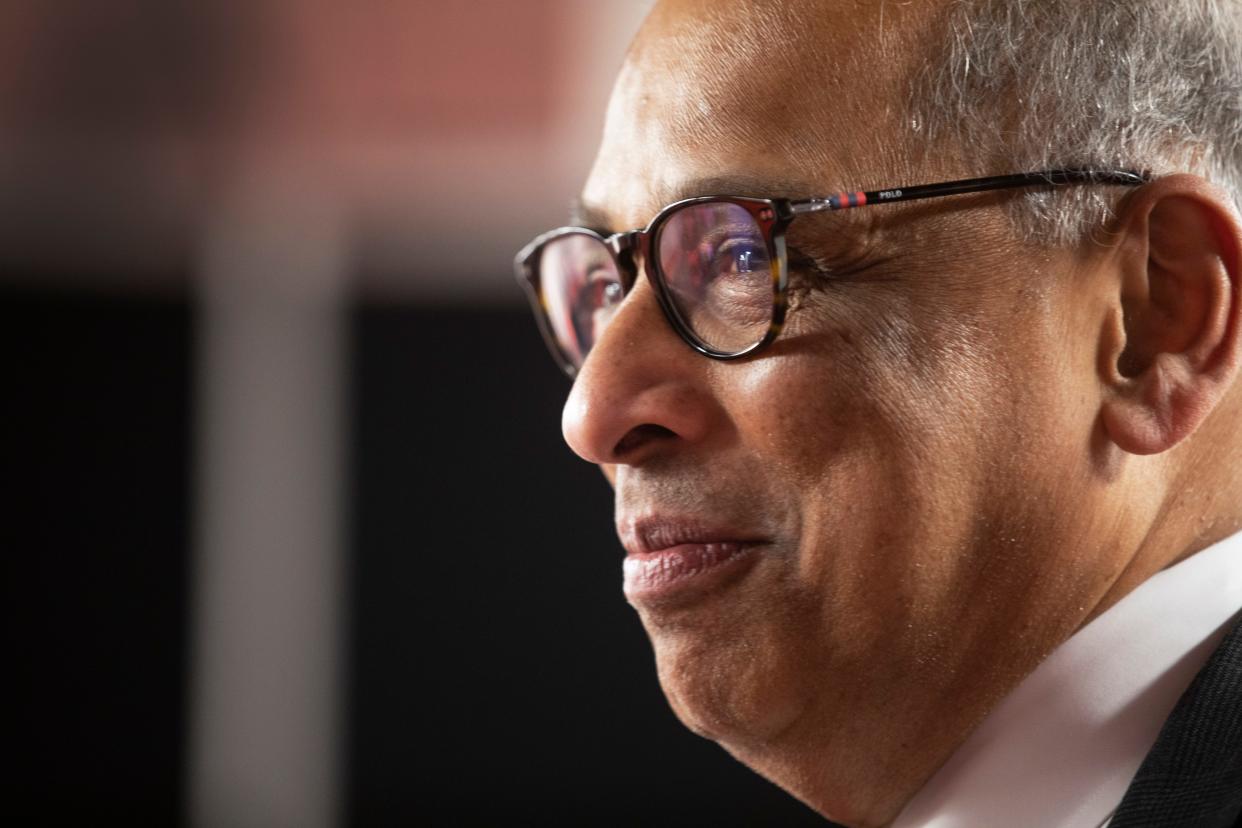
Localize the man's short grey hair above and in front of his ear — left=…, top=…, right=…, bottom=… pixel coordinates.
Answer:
left=910, top=0, right=1242, bottom=245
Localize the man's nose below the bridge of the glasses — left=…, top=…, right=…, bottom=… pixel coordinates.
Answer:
left=561, top=279, right=717, bottom=466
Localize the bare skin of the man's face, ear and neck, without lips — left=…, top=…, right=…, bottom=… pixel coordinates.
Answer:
left=563, top=0, right=1242, bottom=826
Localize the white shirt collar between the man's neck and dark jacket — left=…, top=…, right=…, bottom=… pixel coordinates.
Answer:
left=892, top=533, right=1242, bottom=828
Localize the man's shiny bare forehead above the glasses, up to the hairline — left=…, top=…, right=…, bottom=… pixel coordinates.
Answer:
left=582, top=0, right=941, bottom=227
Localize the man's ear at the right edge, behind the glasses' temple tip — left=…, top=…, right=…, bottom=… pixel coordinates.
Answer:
left=1102, top=175, right=1242, bottom=454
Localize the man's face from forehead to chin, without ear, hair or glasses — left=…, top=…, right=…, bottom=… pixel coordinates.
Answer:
left=564, top=2, right=1137, bottom=804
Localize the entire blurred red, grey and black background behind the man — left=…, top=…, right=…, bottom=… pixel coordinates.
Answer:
left=7, top=0, right=816, bottom=828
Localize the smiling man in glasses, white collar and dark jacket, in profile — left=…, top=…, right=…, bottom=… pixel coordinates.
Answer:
left=519, top=0, right=1242, bottom=828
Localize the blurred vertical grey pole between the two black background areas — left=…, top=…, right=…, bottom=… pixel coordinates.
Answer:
left=188, top=159, right=347, bottom=828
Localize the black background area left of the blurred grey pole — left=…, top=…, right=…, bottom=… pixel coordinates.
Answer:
left=0, top=281, right=193, bottom=826
